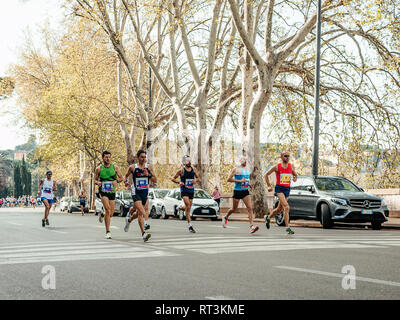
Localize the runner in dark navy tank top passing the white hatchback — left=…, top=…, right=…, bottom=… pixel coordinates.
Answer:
left=171, top=156, right=200, bottom=233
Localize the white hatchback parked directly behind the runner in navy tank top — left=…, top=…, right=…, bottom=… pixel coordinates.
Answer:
left=161, top=188, right=219, bottom=220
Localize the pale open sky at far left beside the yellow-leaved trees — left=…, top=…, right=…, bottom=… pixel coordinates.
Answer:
left=0, top=0, right=63, bottom=150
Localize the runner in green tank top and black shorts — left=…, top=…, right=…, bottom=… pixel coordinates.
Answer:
left=94, top=151, right=123, bottom=239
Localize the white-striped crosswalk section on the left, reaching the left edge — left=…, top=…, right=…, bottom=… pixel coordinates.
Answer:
left=0, top=240, right=179, bottom=265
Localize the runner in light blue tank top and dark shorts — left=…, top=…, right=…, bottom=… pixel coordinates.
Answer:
left=222, top=157, right=258, bottom=233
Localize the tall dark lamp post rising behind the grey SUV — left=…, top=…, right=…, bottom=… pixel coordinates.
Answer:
left=312, top=0, right=321, bottom=176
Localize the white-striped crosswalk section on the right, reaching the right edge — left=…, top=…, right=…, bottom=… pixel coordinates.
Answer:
left=145, top=235, right=400, bottom=254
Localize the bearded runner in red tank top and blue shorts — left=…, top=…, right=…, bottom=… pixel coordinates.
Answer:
left=264, top=152, right=297, bottom=234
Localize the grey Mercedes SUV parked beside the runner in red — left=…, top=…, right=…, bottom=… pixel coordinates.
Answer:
left=275, top=176, right=389, bottom=230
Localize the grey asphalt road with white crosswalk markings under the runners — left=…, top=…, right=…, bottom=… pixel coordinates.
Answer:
left=0, top=208, right=400, bottom=300
